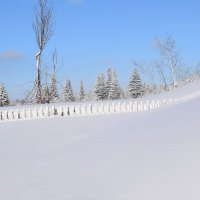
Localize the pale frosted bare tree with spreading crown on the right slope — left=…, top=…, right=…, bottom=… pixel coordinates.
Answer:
left=155, top=35, right=180, bottom=87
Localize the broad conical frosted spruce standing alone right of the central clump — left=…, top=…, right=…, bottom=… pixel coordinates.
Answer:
left=129, top=69, right=144, bottom=98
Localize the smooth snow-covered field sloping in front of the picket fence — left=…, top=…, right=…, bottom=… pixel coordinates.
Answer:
left=0, top=81, right=200, bottom=200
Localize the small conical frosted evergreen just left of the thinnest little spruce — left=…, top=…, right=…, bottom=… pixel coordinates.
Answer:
left=62, top=80, right=75, bottom=102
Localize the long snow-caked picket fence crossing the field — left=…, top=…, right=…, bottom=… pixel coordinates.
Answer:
left=0, top=99, right=177, bottom=122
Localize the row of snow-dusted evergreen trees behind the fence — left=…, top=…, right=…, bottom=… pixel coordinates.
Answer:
left=0, top=65, right=145, bottom=106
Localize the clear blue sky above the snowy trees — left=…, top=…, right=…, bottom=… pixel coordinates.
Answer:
left=0, top=0, right=200, bottom=99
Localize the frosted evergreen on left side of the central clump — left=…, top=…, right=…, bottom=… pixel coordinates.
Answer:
left=95, top=74, right=106, bottom=100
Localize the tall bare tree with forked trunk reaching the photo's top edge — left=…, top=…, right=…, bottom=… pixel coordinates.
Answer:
left=32, top=0, right=54, bottom=103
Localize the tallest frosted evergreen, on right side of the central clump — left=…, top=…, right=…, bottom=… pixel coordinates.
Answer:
left=107, top=70, right=120, bottom=100
